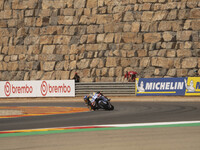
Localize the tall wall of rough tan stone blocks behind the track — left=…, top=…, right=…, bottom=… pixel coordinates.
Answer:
left=0, top=0, right=200, bottom=82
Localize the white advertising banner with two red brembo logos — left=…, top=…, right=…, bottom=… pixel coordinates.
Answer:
left=0, top=80, right=75, bottom=97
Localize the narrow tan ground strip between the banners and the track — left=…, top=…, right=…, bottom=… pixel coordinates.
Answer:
left=0, top=96, right=200, bottom=103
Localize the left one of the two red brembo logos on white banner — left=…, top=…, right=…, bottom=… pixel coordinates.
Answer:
left=4, top=82, right=33, bottom=96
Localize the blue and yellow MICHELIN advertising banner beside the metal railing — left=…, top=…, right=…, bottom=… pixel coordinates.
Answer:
left=135, top=77, right=200, bottom=96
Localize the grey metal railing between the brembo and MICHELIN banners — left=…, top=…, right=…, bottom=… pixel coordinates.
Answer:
left=75, top=82, right=135, bottom=96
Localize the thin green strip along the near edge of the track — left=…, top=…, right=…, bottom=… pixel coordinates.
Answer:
left=0, top=123, right=200, bottom=137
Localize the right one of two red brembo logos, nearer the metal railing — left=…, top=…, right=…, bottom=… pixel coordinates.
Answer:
left=40, top=81, right=71, bottom=96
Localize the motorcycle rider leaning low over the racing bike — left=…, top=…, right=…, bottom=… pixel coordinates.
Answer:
left=84, top=91, right=110, bottom=110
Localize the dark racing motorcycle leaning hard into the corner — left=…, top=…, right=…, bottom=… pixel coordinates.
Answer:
left=84, top=95, right=114, bottom=111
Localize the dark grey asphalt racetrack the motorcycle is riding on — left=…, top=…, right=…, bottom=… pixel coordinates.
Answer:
left=0, top=102, right=200, bottom=131
